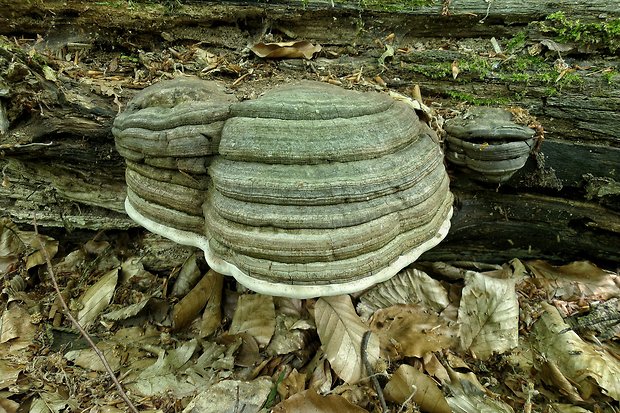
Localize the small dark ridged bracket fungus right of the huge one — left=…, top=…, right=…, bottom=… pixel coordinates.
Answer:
left=444, top=107, right=535, bottom=183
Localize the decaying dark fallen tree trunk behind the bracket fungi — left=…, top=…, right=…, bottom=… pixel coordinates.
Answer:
left=0, top=0, right=620, bottom=264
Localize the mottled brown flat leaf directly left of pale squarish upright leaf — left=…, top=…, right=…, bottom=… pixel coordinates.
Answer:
left=371, top=304, right=456, bottom=359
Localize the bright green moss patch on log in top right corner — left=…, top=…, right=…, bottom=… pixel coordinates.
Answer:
left=542, top=11, right=620, bottom=53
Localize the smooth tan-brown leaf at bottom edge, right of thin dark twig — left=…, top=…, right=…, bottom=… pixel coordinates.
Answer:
left=384, top=364, right=452, bottom=413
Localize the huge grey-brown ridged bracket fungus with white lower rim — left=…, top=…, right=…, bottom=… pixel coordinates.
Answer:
left=113, top=80, right=453, bottom=298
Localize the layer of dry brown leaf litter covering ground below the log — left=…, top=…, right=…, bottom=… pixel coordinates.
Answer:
left=0, top=219, right=620, bottom=412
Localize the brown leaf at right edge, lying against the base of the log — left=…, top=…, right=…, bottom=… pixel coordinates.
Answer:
left=526, top=260, right=620, bottom=301
